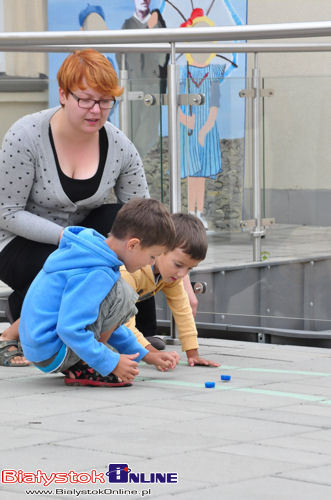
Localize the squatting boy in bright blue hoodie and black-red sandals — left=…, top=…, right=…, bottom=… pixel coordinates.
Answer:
left=19, top=198, right=178, bottom=387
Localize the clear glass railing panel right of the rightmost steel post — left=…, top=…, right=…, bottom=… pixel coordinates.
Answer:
left=263, top=77, right=331, bottom=234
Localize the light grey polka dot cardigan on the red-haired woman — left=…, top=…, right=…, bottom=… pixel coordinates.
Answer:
left=0, top=108, right=149, bottom=251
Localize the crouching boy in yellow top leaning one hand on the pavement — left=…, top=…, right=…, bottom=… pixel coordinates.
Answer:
left=121, top=213, right=219, bottom=366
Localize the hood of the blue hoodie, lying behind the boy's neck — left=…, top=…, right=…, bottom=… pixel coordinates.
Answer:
left=43, top=226, right=123, bottom=273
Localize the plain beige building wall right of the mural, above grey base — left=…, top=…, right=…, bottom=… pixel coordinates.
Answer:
left=245, top=0, right=331, bottom=197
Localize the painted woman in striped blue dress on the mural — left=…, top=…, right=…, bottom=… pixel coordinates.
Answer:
left=179, top=9, right=225, bottom=229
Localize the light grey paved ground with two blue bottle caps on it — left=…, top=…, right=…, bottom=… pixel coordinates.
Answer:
left=0, top=332, right=331, bottom=500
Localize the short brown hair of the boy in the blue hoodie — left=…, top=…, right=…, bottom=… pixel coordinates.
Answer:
left=111, top=198, right=176, bottom=250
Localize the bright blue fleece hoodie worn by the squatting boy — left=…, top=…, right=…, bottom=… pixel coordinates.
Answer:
left=19, top=226, right=148, bottom=375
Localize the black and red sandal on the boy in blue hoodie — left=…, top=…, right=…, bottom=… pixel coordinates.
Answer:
left=62, top=361, right=132, bottom=387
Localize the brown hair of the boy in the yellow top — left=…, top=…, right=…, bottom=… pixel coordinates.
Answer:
left=171, top=213, right=208, bottom=260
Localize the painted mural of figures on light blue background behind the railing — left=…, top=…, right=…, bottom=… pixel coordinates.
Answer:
left=48, top=0, right=247, bottom=229
